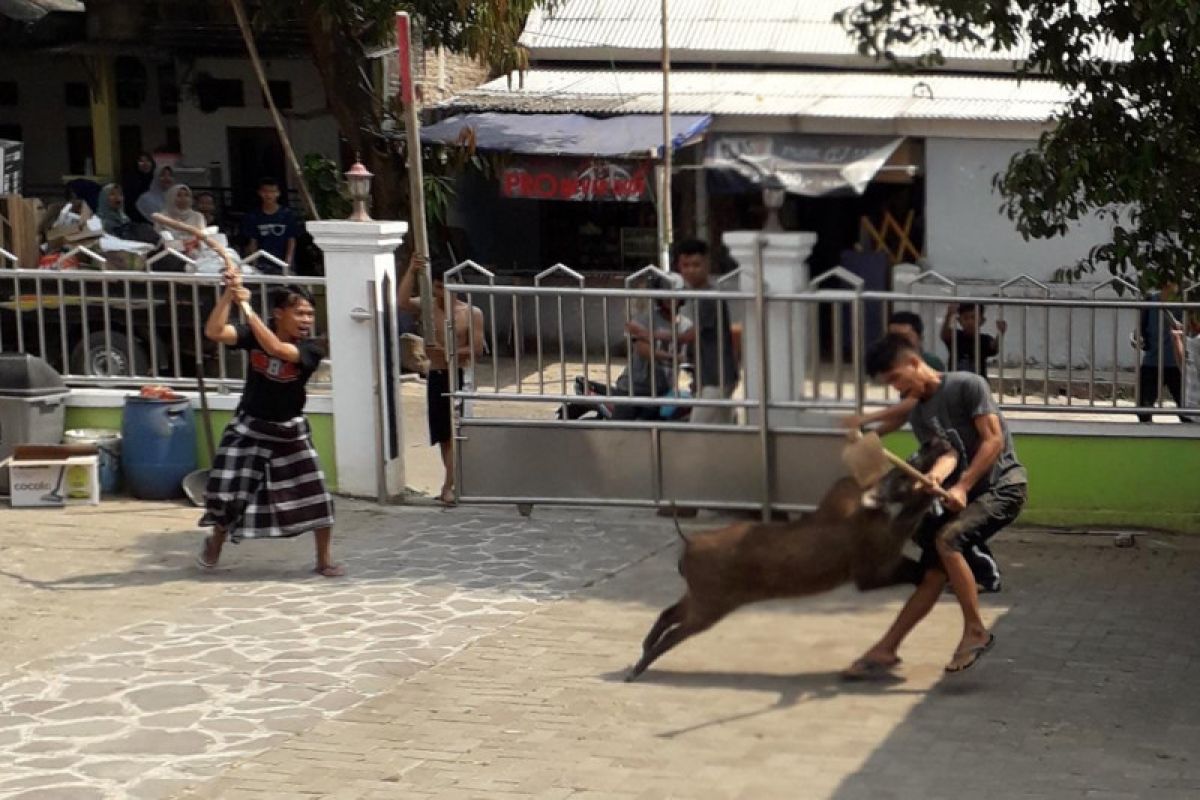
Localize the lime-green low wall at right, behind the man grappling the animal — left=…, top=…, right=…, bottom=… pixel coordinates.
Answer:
left=887, top=432, right=1200, bottom=533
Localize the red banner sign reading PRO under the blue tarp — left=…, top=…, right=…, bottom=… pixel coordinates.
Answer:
left=500, top=158, right=653, bottom=203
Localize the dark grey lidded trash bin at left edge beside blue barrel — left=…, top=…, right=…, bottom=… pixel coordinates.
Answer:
left=0, top=353, right=71, bottom=493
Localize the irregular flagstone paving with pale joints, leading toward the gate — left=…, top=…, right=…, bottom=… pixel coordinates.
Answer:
left=0, top=503, right=670, bottom=799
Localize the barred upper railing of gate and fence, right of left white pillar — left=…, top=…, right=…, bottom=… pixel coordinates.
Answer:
left=446, top=261, right=1200, bottom=426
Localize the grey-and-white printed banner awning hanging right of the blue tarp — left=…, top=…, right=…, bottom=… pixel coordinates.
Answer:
left=704, top=133, right=917, bottom=197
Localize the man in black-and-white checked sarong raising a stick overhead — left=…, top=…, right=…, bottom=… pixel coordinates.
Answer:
left=198, top=269, right=346, bottom=578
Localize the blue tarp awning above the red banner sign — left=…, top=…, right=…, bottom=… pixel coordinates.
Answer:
left=421, top=112, right=713, bottom=156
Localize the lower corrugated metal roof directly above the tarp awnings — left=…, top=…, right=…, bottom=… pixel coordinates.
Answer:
left=442, top=70, right=1068, bottom=122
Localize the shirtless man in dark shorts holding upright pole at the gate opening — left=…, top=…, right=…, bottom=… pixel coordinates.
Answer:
left=400, top=253, right=484, bottom=506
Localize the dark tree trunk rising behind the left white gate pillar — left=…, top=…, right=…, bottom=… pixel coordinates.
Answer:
left=301, top=2, right=409, bottom=219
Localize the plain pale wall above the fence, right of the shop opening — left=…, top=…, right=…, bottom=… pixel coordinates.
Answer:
left=925, top=138, right=1111, bottom=281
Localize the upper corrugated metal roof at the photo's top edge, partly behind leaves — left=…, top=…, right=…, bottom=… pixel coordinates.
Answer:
left=521, top=0, right=1130, bottom=71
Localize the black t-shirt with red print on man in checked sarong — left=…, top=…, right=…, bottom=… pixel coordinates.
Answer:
left=234, top=325, right=325, bottom=422
